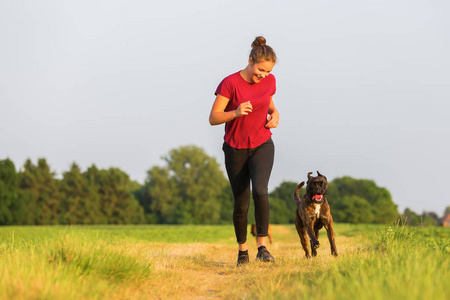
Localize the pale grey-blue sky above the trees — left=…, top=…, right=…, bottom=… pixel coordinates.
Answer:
left=0, top=0, right=450, bottom=216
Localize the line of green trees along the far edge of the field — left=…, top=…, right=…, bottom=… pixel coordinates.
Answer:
left=0, top=145, right=442, bottom=225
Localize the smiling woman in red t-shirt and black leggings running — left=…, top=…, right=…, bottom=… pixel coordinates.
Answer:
left=209, top=36, right=279, bottom=266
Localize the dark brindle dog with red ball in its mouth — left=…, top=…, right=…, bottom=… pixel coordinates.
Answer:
left=294, top=171, right=338, bottom=258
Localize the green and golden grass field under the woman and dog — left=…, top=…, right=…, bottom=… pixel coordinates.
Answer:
left=0, top=224, right=450, bottom=300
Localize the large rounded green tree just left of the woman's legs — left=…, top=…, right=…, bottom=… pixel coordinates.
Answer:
left=140, top=145, right=227, bottom=224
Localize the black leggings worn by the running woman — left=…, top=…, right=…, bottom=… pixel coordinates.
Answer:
left=222, top=138, right=275, bottom=244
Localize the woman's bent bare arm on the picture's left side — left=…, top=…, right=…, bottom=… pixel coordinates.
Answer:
left=209, top=95, right=253, bottom=125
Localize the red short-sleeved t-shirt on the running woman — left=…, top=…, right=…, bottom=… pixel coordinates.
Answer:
left=215, top=72, right=276, bottom=149
